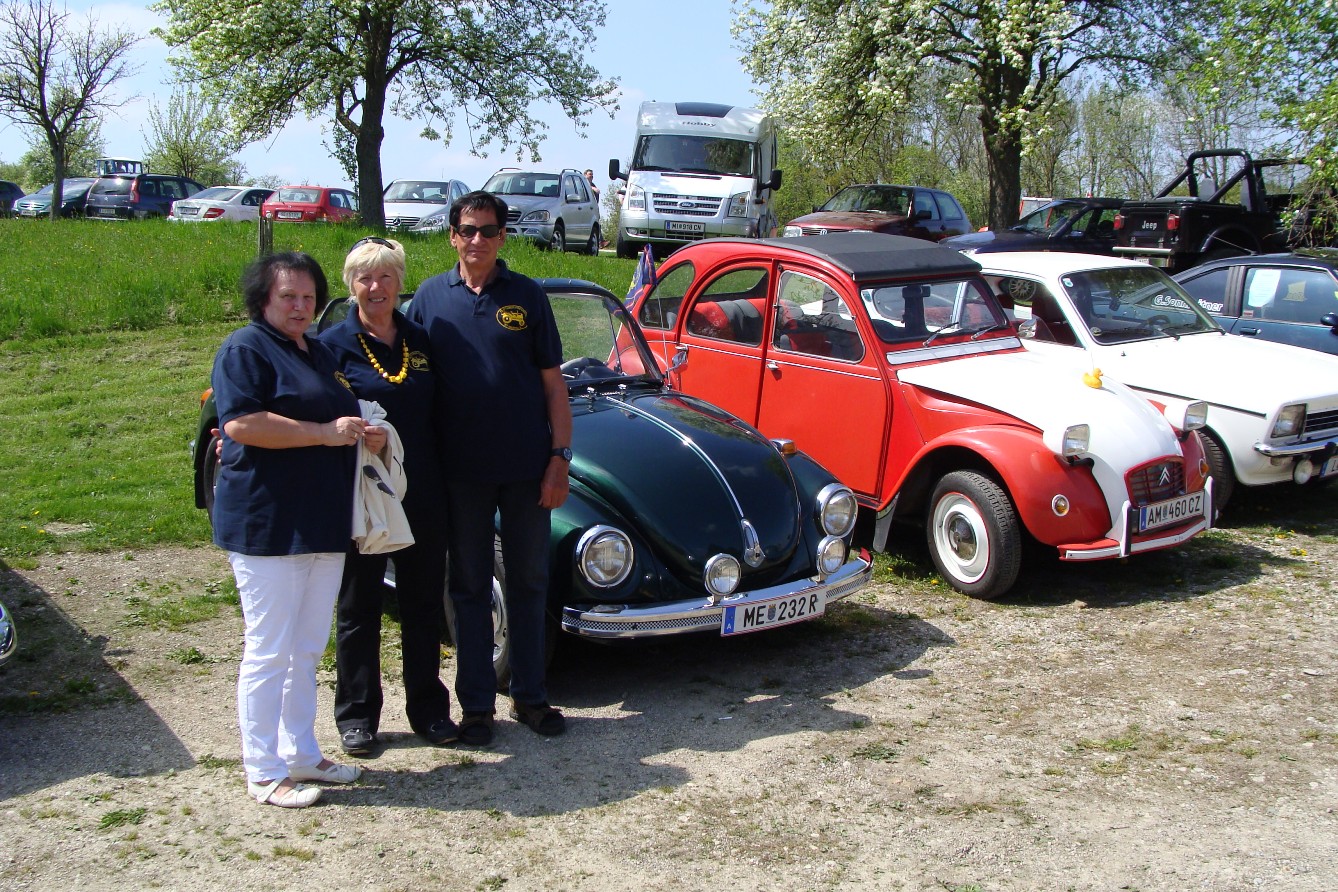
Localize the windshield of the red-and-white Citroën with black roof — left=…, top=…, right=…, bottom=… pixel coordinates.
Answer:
left=859, top=278, right=1008, bottom=344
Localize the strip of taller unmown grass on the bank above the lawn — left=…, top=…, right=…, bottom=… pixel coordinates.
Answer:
left=0, top=219, right=634, bottom=341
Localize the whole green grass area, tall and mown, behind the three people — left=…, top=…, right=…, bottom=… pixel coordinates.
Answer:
left=0, top=219, right=634, bottom=564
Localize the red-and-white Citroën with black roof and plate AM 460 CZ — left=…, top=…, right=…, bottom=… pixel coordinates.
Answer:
left=633, top=233, right=1212, bottom=598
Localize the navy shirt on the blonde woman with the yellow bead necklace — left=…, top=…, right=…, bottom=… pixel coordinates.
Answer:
left=318, top=309, right=443, bottom=527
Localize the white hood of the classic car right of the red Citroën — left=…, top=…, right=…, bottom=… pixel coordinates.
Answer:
left=1093, top=333, right=1338, bottom=417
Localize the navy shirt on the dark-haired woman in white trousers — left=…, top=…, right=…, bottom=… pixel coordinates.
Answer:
left=210, top=320, right=359, bottom=555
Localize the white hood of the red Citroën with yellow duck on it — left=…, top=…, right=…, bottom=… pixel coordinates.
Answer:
left=898, top=352, right=1180, bottom=467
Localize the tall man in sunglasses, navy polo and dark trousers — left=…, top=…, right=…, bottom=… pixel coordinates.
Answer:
left=405, top=191, right=571, bottom=746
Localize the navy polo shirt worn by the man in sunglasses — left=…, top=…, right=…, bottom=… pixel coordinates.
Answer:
left=405, top=261, right=562, bottom=483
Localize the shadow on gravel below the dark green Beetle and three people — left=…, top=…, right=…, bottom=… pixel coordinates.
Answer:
left=332, top=603, right=955, bottom=816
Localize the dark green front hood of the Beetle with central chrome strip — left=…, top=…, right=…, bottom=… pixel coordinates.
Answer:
left=571, top=391, right=801, bottom=576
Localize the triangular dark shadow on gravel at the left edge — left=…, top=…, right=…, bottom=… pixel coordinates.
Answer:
left=0, top=562, right=195, bottom=801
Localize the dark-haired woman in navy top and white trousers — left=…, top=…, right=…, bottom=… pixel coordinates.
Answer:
left=211, top=253, right=385, bottom=808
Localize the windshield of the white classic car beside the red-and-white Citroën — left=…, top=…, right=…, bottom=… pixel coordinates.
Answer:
left=1060, top=266, right=1222, bottom=344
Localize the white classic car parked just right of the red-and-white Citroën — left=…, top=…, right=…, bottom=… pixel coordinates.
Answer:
left=977, top=253, right=1338, bottom=510
